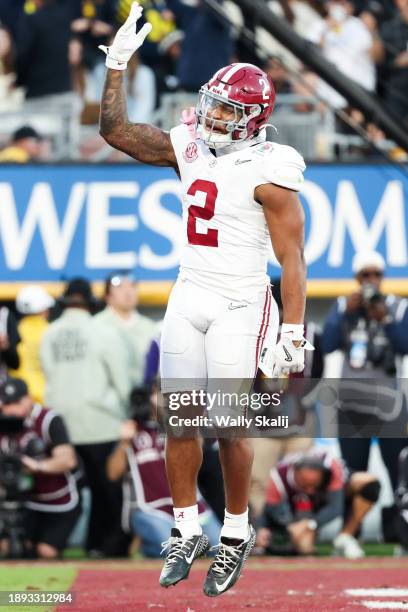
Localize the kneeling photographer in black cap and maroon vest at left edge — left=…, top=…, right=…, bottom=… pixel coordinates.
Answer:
left=0, top=377, right=81, bottom=559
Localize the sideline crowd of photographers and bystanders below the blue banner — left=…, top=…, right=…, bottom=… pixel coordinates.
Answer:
left=0, top=252, right=408, bottom=558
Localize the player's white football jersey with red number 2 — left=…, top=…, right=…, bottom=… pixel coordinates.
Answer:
left=170, top=125, right=305, bottom=300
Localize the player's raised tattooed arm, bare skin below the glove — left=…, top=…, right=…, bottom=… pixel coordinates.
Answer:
left=100, top=69, right=177, bottom=169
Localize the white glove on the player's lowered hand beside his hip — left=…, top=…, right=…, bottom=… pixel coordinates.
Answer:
left=259, top=323, right=314, bottom=378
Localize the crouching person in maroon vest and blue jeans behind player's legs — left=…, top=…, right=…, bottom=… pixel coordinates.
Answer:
left=107, top=389, right=221, bottom=557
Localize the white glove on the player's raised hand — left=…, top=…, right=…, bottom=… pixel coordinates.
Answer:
left=98, top=2, right=152, bottom=70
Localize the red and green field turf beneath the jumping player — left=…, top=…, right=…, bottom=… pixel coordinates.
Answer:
left=0, top=549, right=408, bottom=612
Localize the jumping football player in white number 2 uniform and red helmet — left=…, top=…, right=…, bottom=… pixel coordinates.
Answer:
left=100, top=2, right=306, bottom=596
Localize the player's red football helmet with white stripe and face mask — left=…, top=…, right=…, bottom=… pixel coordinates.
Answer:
left=196, top=64, right=276, bottom=148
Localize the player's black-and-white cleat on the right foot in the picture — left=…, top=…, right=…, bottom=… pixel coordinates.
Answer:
left=204, top=525, right=256, bottom=597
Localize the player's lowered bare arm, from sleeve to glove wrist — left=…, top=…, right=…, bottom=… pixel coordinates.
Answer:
left=255, top=184, right=306, bottom=324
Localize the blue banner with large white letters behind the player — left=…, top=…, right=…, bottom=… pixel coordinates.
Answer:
left=0, top=164, right=408, bottom=283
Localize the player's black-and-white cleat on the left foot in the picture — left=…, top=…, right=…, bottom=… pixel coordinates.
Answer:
left=160, top=527, right=209, bottom=587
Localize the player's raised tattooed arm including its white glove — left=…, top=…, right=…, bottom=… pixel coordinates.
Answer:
left=99, top=2, right=177, bottom=170
